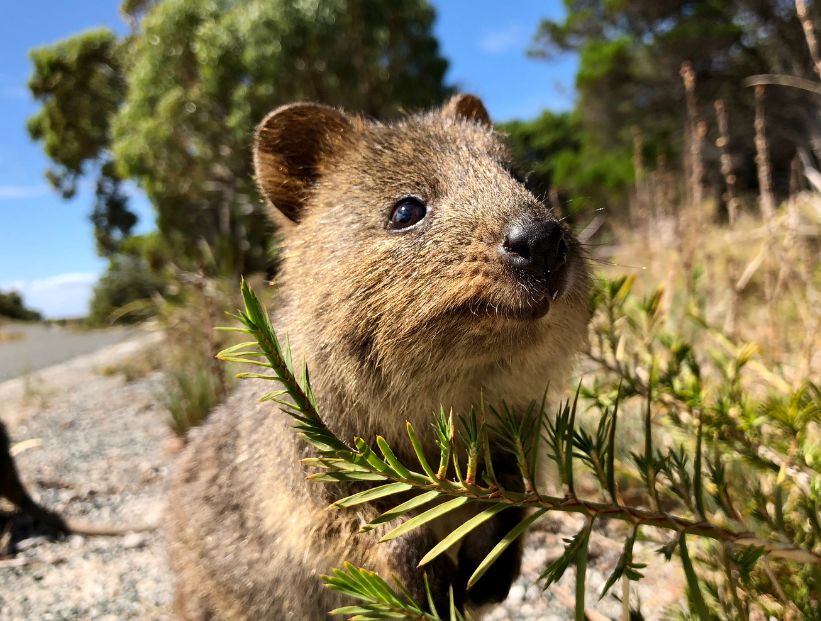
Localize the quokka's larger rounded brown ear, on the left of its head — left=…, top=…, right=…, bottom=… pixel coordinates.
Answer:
left=254, top=103, right=352, bottom=222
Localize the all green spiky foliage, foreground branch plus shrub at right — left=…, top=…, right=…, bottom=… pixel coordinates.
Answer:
left=221, top=279, right=821, bottom=620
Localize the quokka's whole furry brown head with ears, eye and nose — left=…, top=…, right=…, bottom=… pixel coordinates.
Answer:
left=254, top=95, right=589, bottom=388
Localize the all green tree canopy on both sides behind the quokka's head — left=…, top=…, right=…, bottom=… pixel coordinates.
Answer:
left=29, top=0, right=821, bottom=320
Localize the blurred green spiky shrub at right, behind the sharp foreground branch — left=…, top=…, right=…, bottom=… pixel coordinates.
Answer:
left=582, top=271, right=821, bottom=619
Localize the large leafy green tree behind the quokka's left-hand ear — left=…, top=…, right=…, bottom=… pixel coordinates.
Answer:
left=30, top=0, right=448, bottom=274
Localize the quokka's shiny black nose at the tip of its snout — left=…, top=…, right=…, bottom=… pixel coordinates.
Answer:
left=502, top=222, right=570, bottom=278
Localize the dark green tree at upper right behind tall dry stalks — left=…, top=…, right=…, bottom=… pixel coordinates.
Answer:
left=531, top=0, right=821, bottom=208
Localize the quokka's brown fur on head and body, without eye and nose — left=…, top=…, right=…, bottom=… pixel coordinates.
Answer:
left=168, top=95, right=589, bottom=620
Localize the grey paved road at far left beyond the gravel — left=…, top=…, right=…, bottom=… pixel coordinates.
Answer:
left=0, top=323, right=135, bottom=382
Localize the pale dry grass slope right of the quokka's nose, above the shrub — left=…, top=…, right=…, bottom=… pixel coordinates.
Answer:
left=600, top=193, right=821, bottom=386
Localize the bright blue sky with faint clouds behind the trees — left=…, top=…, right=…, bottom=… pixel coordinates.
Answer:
left=0, top=0, right=576, bottom=317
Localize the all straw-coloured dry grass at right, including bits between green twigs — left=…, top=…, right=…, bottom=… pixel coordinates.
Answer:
left=581, top=195, right=821, bottom=619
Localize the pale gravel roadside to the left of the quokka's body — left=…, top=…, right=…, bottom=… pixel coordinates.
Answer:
left=0, top=335, right=173, bottom=621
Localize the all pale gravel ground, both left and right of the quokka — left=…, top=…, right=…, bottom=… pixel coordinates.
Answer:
left=0, top=335, right=683, bottom=621
